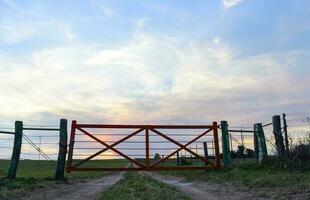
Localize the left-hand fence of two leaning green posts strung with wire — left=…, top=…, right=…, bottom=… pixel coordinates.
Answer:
left=0, top=119, right=67, bottom=179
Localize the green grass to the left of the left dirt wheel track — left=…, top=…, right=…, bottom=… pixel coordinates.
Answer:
left=0, top=160, right=127, bottom=199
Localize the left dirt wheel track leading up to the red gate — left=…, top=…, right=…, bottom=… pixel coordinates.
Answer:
left=21, top=172, right=124, bottom=200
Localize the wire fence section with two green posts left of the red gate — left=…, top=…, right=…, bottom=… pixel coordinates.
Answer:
left=0, top=119, right=67, bottom=179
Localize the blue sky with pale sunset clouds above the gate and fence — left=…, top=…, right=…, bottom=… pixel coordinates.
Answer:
left=0, top=0, right=310, bottom=159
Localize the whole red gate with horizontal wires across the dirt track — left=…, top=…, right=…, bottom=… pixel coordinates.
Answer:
left=66, top=121, right=221, bottom=173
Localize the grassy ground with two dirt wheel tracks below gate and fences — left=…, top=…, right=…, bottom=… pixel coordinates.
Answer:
left=0, top=161, right=310, bottom=200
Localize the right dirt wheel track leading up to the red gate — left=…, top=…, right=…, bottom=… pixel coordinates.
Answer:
left=147, top=173, right=263, bottom=200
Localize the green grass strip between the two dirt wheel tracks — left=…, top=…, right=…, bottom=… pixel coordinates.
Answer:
left=96, top=172, right=189, bottom=200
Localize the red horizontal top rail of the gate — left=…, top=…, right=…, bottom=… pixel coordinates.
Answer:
left=76, top=124, right=213, bottom=129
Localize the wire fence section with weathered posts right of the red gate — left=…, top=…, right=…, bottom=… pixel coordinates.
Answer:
left=219, top=114, right=310, bottom=167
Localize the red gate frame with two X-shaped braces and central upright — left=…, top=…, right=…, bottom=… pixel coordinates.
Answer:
left=66, top=120, right=221, bottom=173
